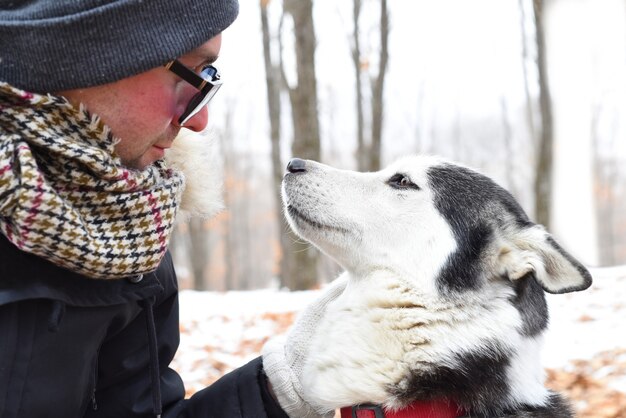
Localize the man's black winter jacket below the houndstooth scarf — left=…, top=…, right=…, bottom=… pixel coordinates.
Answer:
left=0, top=234, right=287, bottom=418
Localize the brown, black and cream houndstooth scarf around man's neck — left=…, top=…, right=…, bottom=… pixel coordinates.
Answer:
left=0, top=82, right=184, bottom=279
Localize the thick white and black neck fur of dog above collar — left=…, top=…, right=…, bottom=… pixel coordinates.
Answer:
left=304, top=272, right=549, bottom=409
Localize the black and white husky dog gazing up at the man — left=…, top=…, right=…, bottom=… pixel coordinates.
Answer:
left=282, top=156, right=591, bottom=418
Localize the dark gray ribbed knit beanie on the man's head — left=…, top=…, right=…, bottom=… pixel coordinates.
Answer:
left=0, top=0, right=239, bottom=93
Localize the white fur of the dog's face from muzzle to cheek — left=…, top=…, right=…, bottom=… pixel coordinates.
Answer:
left=283, top=158, right=456, bottom=292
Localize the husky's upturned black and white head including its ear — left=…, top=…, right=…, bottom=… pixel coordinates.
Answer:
left=283, top=156, right=591, bottom=293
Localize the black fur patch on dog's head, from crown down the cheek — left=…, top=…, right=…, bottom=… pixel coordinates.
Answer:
left=428, top=164, right=532, bottom=292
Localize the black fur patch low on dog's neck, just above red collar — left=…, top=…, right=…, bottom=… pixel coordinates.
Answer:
left=390, top=343, right=510, bottom=417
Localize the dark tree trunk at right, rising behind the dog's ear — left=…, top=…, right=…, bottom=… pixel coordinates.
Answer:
left=533, top=0, right=554, bottom=230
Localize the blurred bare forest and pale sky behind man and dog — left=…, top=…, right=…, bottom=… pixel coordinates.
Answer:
left=166, top=0, right=626, bottom=291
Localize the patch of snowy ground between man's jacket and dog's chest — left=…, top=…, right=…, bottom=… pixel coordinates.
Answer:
left=173, top=290, right=318, bottom=394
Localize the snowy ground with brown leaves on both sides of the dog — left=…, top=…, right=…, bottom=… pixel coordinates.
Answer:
left=173, top=266, right=626, bottom=417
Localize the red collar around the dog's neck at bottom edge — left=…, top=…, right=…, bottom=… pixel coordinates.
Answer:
left=341, top=401, right=464, bottom=418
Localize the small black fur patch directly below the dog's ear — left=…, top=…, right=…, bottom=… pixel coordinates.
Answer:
left=511, top=273, right=548, bottom=337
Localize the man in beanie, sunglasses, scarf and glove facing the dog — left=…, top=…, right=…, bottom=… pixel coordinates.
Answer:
left=0, top=0, right=341, bottom=418
